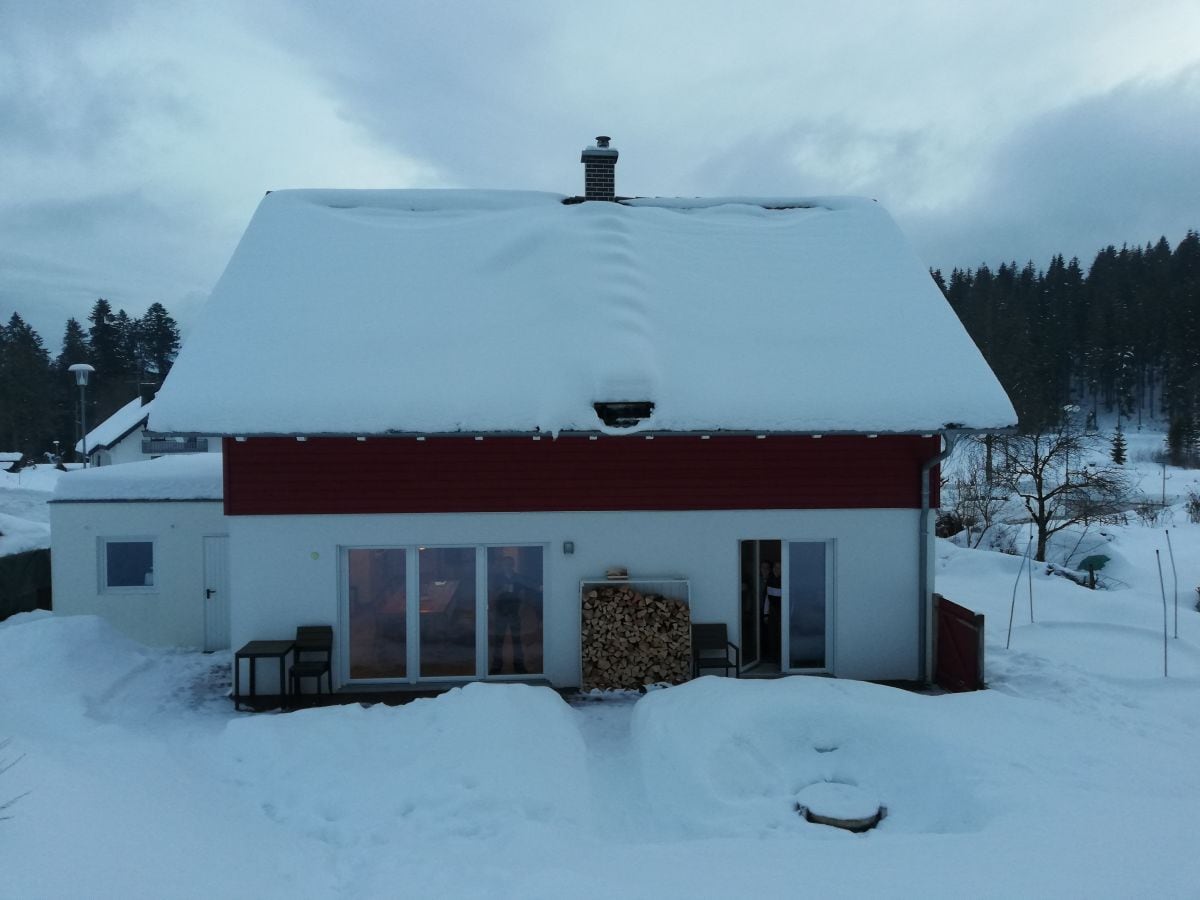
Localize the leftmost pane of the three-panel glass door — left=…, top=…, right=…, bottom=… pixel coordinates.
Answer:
left=347, top=550, right=408, bottom=678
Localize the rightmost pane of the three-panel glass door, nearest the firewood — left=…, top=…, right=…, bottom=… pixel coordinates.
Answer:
left=487, top=547, right=544, bottom=674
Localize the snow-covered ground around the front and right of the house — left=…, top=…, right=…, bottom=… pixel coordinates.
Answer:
left=7, top=434, right=1200, bottom=900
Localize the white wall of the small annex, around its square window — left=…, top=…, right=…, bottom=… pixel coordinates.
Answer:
left=50, top=500, right=227, bottom=648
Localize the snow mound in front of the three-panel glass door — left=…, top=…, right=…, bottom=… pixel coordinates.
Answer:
left=221, top=684, right=589, bottom=847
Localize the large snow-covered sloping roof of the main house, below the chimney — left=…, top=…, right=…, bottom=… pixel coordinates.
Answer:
left=150, top=191, right=1016, bottom=434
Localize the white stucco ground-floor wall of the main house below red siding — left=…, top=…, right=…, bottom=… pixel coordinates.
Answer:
left=228, top=510, right=919, bottom=691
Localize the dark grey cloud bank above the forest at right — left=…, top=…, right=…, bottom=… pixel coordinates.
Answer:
left=896, top=66, right=1200, bottom=269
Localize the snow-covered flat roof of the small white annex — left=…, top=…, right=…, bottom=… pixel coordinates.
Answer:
left=54, top=454, right=224, bottom=502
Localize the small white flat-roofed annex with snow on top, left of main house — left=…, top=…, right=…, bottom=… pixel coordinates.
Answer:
left=50, top=454, right=229, bottom=650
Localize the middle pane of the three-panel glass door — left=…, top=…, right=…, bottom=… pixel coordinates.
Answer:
left=418, top=547, right=475, bottom=678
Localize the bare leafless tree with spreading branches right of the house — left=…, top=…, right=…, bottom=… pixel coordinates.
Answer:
left=997, top=424, right=1130, bottom=563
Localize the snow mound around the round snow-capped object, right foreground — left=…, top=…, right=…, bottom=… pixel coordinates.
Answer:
left=632, top=677, right=979, bottom=836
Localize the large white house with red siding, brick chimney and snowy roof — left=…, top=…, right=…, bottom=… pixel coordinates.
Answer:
left=129, top=142, right=1016, bottom=688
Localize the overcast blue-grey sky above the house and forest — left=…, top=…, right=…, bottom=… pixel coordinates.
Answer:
left=0, top=0, right=1200, bottom=353
